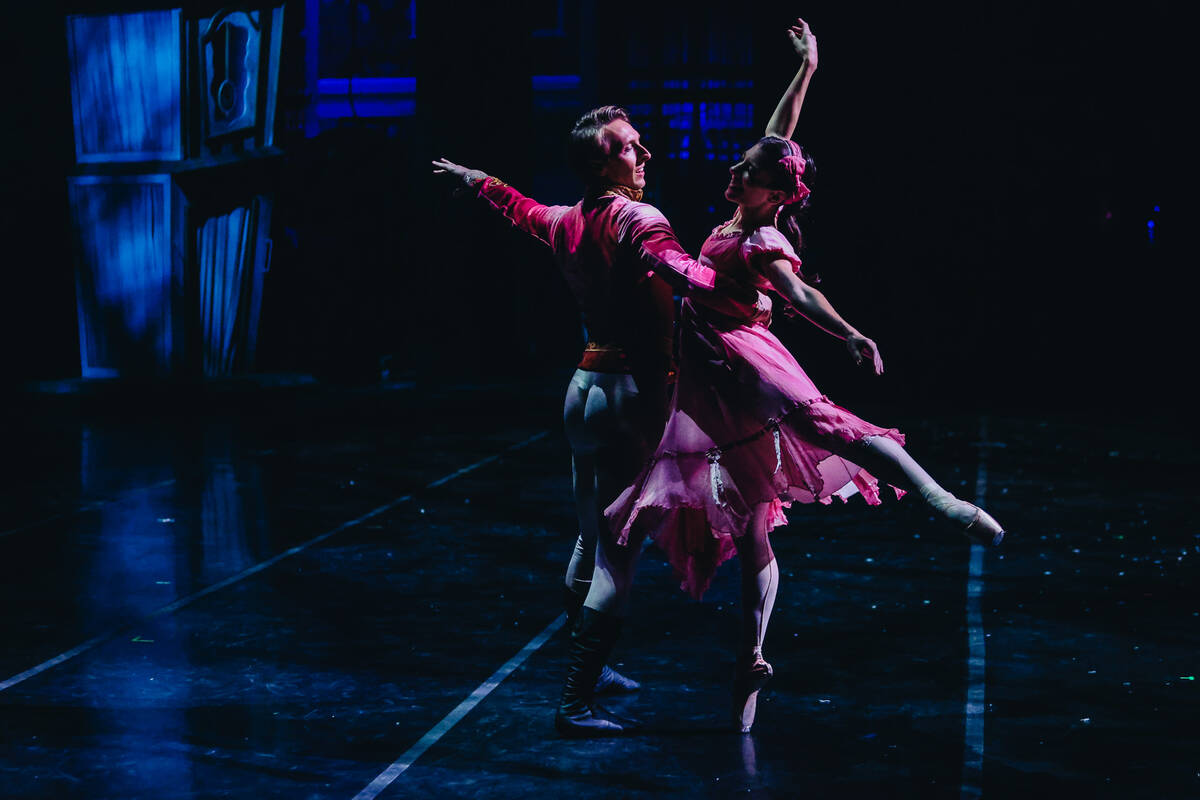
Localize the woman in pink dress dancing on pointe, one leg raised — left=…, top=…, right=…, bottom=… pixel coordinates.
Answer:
left=605, top=20, right=1004, bottom=732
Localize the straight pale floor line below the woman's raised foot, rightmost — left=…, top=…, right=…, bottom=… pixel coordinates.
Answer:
left=959, top=416, right=989, bottom=800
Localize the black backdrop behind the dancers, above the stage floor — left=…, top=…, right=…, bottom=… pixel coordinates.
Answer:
left=0, top=2, right=1180, bottom=419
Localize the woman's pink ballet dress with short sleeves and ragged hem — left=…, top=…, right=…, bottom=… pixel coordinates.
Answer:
left=605, top=221, right=904, bottom=599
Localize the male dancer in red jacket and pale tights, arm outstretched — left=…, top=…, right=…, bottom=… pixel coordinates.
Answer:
left=433, top=106, right=716, bottom=735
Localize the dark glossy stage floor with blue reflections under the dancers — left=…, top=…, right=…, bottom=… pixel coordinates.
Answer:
left=0, top=381, right=1200, bottom=800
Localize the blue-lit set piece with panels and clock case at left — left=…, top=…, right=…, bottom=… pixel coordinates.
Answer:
left=66, top=5, right=283, bottom=378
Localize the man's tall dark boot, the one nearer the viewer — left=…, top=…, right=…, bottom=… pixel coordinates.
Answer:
left=554, top=606, right=637, bottom=739
